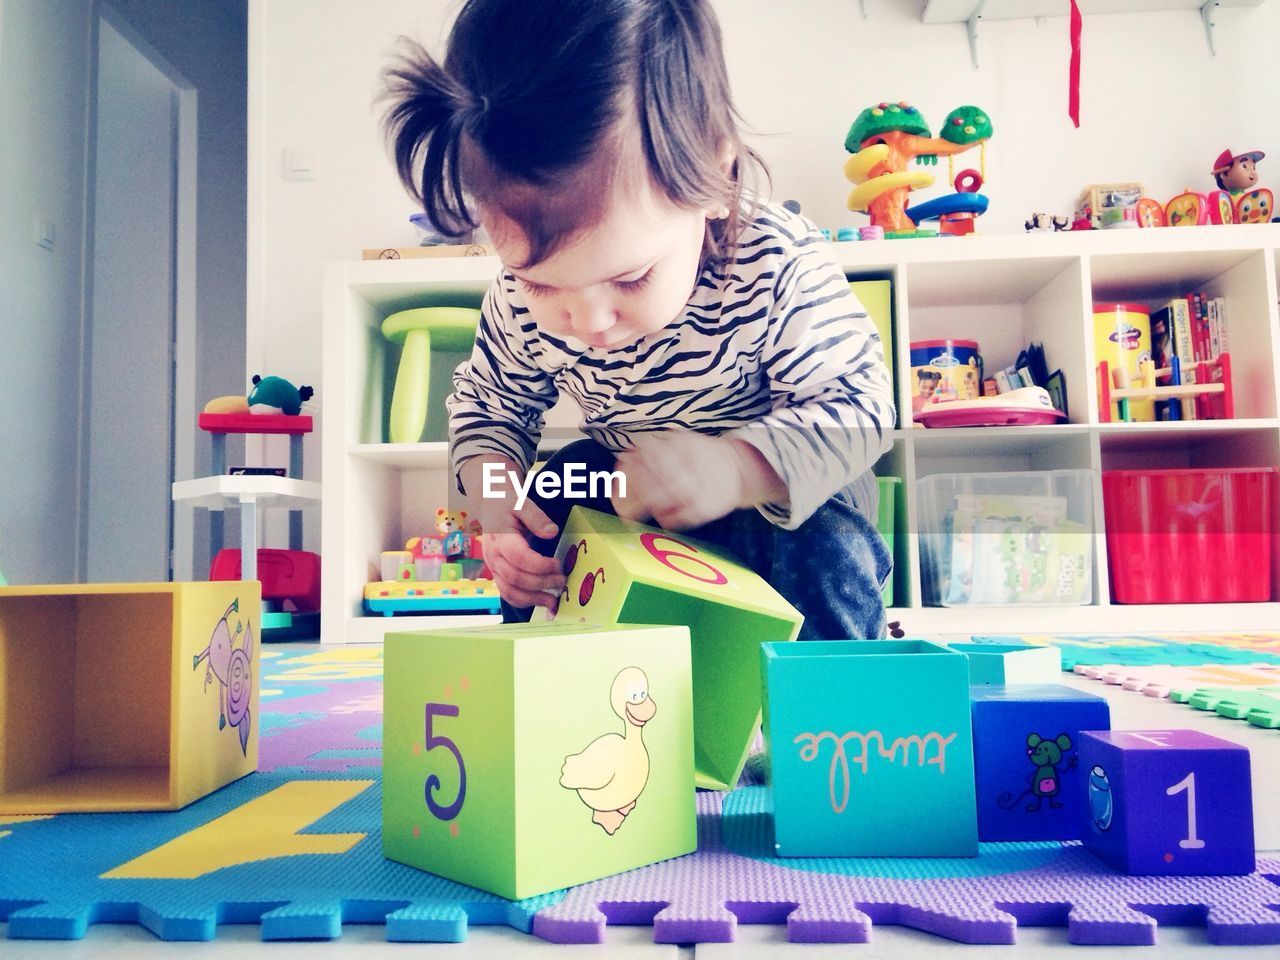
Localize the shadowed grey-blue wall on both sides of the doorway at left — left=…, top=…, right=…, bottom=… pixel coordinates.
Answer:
left=0, top=0, right=247, bottom=582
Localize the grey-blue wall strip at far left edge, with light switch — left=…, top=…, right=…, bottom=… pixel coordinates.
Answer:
left=0, top=0, right=90, bottom=582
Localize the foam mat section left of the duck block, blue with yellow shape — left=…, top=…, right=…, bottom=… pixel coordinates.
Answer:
left=0, top=648, right=558, bottom=941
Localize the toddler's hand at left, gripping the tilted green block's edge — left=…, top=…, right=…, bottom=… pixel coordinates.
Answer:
left=462, top=458, right=564, bottom=613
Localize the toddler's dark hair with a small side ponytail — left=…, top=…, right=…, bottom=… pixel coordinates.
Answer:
left=385, top=0, right=764, bottom=266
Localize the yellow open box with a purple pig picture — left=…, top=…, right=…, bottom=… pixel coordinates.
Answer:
left=0, top=580, right=261, bottom=814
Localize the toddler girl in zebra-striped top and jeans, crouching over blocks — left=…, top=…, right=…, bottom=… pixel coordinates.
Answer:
left=387, top=0, right=893, bottom=639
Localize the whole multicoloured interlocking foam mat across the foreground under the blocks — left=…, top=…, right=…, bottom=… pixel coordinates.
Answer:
left=0, top=645, right=1280, bottom=945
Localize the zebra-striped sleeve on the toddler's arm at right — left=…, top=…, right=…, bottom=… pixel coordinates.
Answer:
left=727, top=243, right=893, bottom=530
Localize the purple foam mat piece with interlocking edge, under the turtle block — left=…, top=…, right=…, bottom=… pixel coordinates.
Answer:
left=534, top=787, right=1280, bottom=945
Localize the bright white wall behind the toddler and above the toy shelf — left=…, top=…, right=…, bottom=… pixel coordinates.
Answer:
left=247, top=0, right=1280, bottom=549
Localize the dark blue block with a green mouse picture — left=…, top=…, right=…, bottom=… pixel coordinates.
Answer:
left=969, top=686, right=1111, bottom=841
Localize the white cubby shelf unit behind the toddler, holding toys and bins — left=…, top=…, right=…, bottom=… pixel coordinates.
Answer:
left=321, top=224, right=1280, bottom=643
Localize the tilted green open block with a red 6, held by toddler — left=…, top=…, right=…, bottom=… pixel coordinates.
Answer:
left=556, top=507, right=804, bottom=790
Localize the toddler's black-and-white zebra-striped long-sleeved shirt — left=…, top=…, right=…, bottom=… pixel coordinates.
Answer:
left=448, top=204, right=895, bottom=529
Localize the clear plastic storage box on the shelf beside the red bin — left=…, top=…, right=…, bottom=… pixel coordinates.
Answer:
left=916, top=470, right=1093, bottom=607
